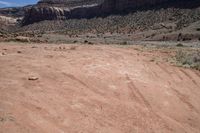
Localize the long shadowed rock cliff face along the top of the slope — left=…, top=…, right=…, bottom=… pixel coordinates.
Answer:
left=22, top=0, right=199, bottom=25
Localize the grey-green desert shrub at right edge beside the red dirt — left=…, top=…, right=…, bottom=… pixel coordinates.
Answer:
left=176, top=50, right=200, bottom=70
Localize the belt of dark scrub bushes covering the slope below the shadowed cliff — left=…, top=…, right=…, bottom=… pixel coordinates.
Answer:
left=12, top=8, right=200, bottom=35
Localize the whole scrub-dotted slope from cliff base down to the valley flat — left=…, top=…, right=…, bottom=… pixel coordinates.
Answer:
left=8, top=7, right=197, bottom=41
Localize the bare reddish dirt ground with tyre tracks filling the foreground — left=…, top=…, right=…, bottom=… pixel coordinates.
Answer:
left=0, top=44, right=200, bottom=133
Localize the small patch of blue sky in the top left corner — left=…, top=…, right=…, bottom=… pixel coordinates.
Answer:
left=0, top=0, right=38, bottom=8
